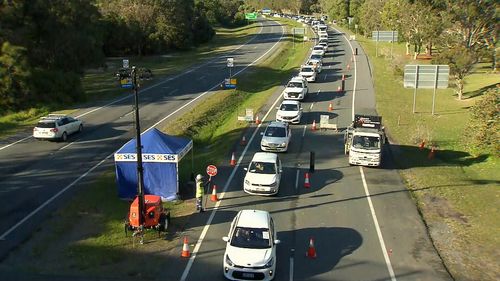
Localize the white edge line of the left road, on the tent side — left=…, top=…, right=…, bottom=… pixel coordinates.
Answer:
left=0, top=20, right=274, bottom=240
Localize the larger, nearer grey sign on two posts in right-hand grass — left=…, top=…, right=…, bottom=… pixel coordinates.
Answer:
left=403, top=64, right=450, bottom=115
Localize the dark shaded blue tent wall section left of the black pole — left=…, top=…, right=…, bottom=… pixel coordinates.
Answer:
left=115, top=162, right=137, bottom=199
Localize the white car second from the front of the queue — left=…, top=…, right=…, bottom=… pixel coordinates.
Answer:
left=243, top=152, right=283, bottom=195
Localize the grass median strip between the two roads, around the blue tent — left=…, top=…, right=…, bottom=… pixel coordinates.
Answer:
left=2, top=18, right=310, bottom=279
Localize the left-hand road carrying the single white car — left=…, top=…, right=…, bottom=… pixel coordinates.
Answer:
left=0, top=21, right=284, bottom=259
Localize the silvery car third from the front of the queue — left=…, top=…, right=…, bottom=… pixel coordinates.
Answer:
left=260, top=121, right=292, bottom=152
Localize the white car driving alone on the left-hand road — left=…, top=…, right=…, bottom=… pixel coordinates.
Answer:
left=33, top=114, right=83, bottom=141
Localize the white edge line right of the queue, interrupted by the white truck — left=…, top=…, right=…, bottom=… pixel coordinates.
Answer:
left=335, top=26, right=396, bottom=281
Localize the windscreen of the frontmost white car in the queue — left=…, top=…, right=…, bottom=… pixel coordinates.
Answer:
left=231, top=227, right=271, bottom=249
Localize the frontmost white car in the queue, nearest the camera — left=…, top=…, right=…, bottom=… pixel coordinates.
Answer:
left=222, top=210, right=280, bottom=281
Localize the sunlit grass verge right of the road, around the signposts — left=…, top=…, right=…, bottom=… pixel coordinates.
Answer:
left=357, top=29, right=500, bottom=280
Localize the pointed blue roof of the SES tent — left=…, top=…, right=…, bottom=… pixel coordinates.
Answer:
left=116, top=128, right=191, bottom=154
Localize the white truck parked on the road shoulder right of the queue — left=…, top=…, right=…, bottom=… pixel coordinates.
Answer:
left=344, top=114, right=386, bottom=167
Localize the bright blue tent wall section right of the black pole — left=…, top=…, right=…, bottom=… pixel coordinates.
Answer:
left=143, top=163, right=177, bottom=201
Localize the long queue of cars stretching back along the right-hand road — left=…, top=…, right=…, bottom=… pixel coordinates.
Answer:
left=226, top=14, right=328, bottom=281
